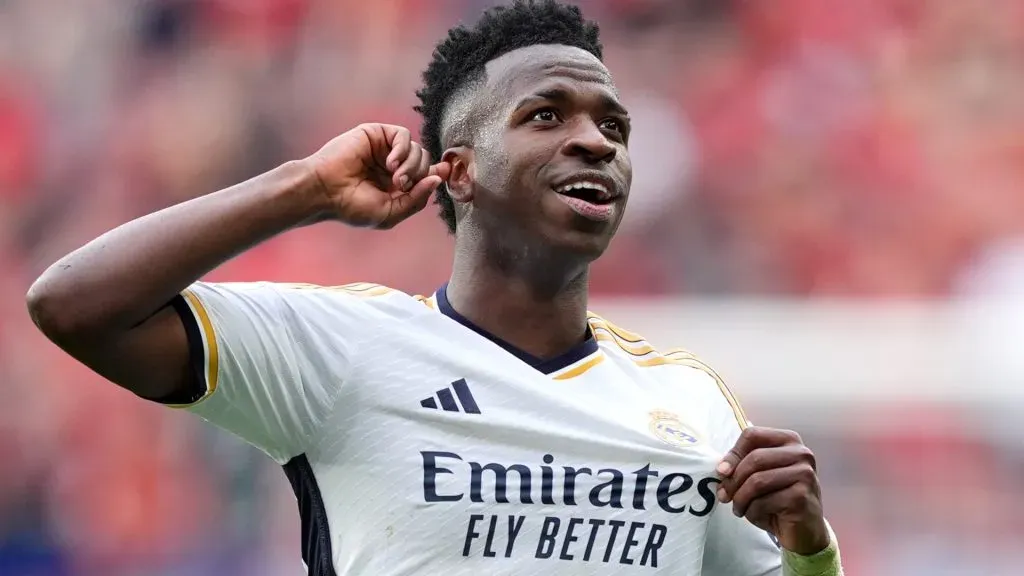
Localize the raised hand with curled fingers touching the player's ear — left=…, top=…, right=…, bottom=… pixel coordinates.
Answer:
left=304, top=124, right=451, bottom=230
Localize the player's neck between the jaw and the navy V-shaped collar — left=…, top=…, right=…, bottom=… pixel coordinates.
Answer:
left=446, top=233, right=588, bottom=359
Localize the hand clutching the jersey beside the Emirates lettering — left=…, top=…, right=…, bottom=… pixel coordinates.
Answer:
left=718, top=426, right=829, bottom=556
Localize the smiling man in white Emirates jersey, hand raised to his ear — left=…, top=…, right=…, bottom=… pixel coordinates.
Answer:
left=29, top=1, right=840, bottom=576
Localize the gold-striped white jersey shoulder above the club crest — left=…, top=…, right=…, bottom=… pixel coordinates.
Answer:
left=588, top=312, right=750, bottom=428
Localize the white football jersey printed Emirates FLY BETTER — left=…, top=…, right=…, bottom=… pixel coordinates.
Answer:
left=161, top=283, right=781, bottom=576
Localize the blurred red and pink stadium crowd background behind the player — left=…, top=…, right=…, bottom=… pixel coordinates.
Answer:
left=0, top=0, right=1024, bottom=576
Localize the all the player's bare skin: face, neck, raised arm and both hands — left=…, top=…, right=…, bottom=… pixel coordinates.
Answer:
left=27, top=42, right=828, bottom=554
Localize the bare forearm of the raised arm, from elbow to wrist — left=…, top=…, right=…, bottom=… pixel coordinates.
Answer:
left=29, top=156, right=326, bottom=335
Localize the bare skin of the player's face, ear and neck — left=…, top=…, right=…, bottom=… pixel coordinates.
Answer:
left=442, top=46, right=633, bottom=358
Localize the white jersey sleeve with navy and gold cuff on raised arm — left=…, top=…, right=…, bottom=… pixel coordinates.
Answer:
left=162, top=282, right=366, bottom=463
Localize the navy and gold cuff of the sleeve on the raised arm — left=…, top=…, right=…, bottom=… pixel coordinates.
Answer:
left=154, top=290, right=218, bottom=408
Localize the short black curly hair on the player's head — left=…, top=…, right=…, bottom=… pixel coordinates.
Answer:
left=414, top=0, right=602, bottom=234
